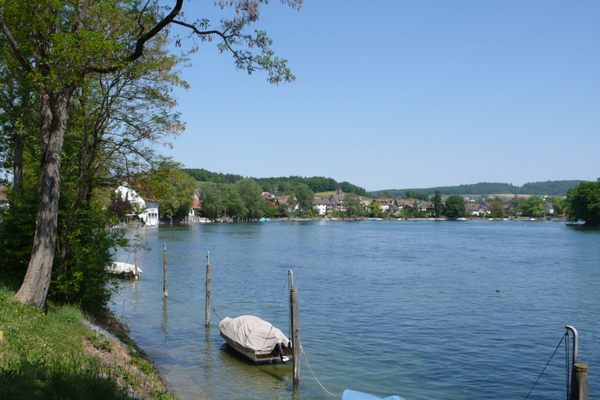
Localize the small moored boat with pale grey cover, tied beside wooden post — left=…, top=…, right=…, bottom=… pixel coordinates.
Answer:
left=219, top=315, right=292, bottom=364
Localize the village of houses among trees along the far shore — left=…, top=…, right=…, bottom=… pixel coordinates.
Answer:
left=112, top=184, right=565, bottom=226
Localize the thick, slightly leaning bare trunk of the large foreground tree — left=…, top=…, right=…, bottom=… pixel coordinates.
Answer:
left=15, top=88, right=72, bottom=308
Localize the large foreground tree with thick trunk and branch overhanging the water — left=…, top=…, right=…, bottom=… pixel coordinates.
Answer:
left=0, top=0, right=302, bottom=307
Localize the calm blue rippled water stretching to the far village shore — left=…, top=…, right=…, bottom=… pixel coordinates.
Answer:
left=113, top=221, right=600, bottom=400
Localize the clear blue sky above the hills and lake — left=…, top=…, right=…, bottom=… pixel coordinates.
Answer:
left=167, top=0, right=600, bottom=190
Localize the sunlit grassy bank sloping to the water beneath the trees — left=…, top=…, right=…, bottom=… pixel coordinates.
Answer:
left=0, top=287, right=173, bottom=400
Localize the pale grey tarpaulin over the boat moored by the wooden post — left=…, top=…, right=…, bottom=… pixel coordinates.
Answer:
left=219, top=315, right=290, bottom=354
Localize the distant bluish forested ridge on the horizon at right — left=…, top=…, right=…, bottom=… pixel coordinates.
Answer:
left=369, top=180, right=581, bottom=197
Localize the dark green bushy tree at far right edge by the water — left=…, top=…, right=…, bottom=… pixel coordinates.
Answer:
left=567, top=179, right=600, bottom=226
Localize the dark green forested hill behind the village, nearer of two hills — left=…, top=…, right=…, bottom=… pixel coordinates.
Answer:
left=182, top=168, right=367, bottom=195
